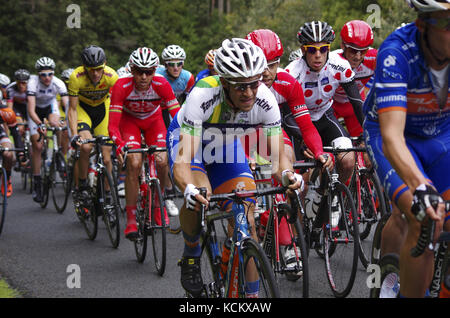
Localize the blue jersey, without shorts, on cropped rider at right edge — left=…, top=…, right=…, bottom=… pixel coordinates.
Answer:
left=364, top=23, right=450, bottom=138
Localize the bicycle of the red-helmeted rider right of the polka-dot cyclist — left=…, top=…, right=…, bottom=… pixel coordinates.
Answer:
left=324, top=138, right=388, bottom=268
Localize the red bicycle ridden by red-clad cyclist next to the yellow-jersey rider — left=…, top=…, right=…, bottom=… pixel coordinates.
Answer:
left=124, top=146, right=168, bottom=276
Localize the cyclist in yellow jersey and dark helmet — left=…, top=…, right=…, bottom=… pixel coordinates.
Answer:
left=67, top=45, right=118, bottom=200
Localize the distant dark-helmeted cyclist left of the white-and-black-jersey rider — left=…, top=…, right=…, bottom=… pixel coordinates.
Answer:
left=6, top=69, right=30, bottom=165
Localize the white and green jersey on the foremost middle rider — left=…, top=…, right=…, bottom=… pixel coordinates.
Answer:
left=177, top=76, right=281, bottom=140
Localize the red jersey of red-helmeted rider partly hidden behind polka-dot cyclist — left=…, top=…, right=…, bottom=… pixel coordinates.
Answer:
left=333, top=49, right=378, bottom=137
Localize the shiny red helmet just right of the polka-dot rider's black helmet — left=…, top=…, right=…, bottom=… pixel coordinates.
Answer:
left=341, top=20, right=373, bottom=48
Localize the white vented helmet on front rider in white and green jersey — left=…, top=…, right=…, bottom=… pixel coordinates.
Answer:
left=214, top=38, right=267, bottom=78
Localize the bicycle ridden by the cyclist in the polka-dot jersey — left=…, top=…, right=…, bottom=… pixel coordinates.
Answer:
left=293, top=153, right=360, bottom=298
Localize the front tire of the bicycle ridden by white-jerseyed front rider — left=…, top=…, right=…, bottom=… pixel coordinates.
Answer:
left=239, top=238, right=280, bottom=298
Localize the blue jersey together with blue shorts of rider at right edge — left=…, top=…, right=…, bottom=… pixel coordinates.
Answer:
left=364, top=23, right=450, bottom=202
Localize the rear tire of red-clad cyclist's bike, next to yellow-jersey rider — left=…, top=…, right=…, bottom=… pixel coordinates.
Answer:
left=134, top=184, right=151, bottom=263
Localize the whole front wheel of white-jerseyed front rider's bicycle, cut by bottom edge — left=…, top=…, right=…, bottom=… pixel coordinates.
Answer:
left=239, top=239, right=280, bottom=298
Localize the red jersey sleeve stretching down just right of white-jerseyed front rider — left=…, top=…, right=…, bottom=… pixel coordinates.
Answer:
left=270, top=70, right=324, bottom=158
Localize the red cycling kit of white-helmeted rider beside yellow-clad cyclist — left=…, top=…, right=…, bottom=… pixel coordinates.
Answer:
left=108, top=74, right=180, bottom=147
